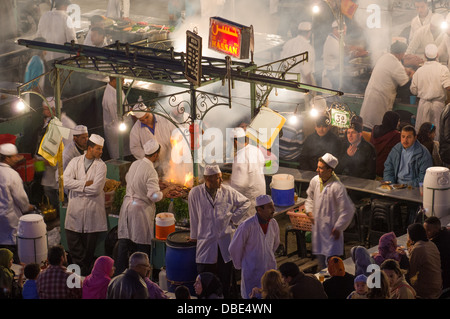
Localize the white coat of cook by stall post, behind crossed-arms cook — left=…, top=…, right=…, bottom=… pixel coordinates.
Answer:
left=102, top=83, right=133, bottom=159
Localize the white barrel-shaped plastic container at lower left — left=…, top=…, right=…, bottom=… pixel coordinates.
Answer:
left=17, top=214, right=48, bottom=264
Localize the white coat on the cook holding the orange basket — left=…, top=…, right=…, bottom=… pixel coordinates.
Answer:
left=305, top=175, right=355, bottom=257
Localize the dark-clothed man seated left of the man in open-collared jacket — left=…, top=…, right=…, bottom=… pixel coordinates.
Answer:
left=299, top=115, right=342, bottom=171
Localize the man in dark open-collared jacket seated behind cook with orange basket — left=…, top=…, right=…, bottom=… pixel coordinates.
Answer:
left=336, top=122, right=376, bottom=179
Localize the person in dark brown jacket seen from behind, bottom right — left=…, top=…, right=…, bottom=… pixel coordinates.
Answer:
left=406, top=224, right=442, bottom=299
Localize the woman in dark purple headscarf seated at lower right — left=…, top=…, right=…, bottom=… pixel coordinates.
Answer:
left=372, top=232, right=409, bottom=269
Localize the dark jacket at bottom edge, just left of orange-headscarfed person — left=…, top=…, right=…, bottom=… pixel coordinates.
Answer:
left=289, top=272, right=328, bottom=299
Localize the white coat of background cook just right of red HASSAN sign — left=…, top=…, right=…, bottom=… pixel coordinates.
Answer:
left=280, top=35, right=316, bottom=85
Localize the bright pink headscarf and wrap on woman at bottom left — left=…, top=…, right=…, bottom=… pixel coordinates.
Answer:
left=83, top=256, right=114, bottom=299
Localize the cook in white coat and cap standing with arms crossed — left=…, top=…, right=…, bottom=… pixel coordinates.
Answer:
left=64, top=134, right=108, bottom=276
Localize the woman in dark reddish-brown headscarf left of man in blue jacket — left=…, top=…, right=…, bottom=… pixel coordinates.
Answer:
left=370, top=111, right=400, bottom=177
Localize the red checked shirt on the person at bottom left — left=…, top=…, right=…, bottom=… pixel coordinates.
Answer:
left=37, top=265, right=81, bottom=299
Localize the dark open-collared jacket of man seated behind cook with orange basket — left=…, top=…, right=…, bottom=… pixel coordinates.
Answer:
left=336, top=138, right=376, bottom=179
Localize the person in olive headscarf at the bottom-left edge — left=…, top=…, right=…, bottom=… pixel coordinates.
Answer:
left=0, top=248, right=23, bottom=299
